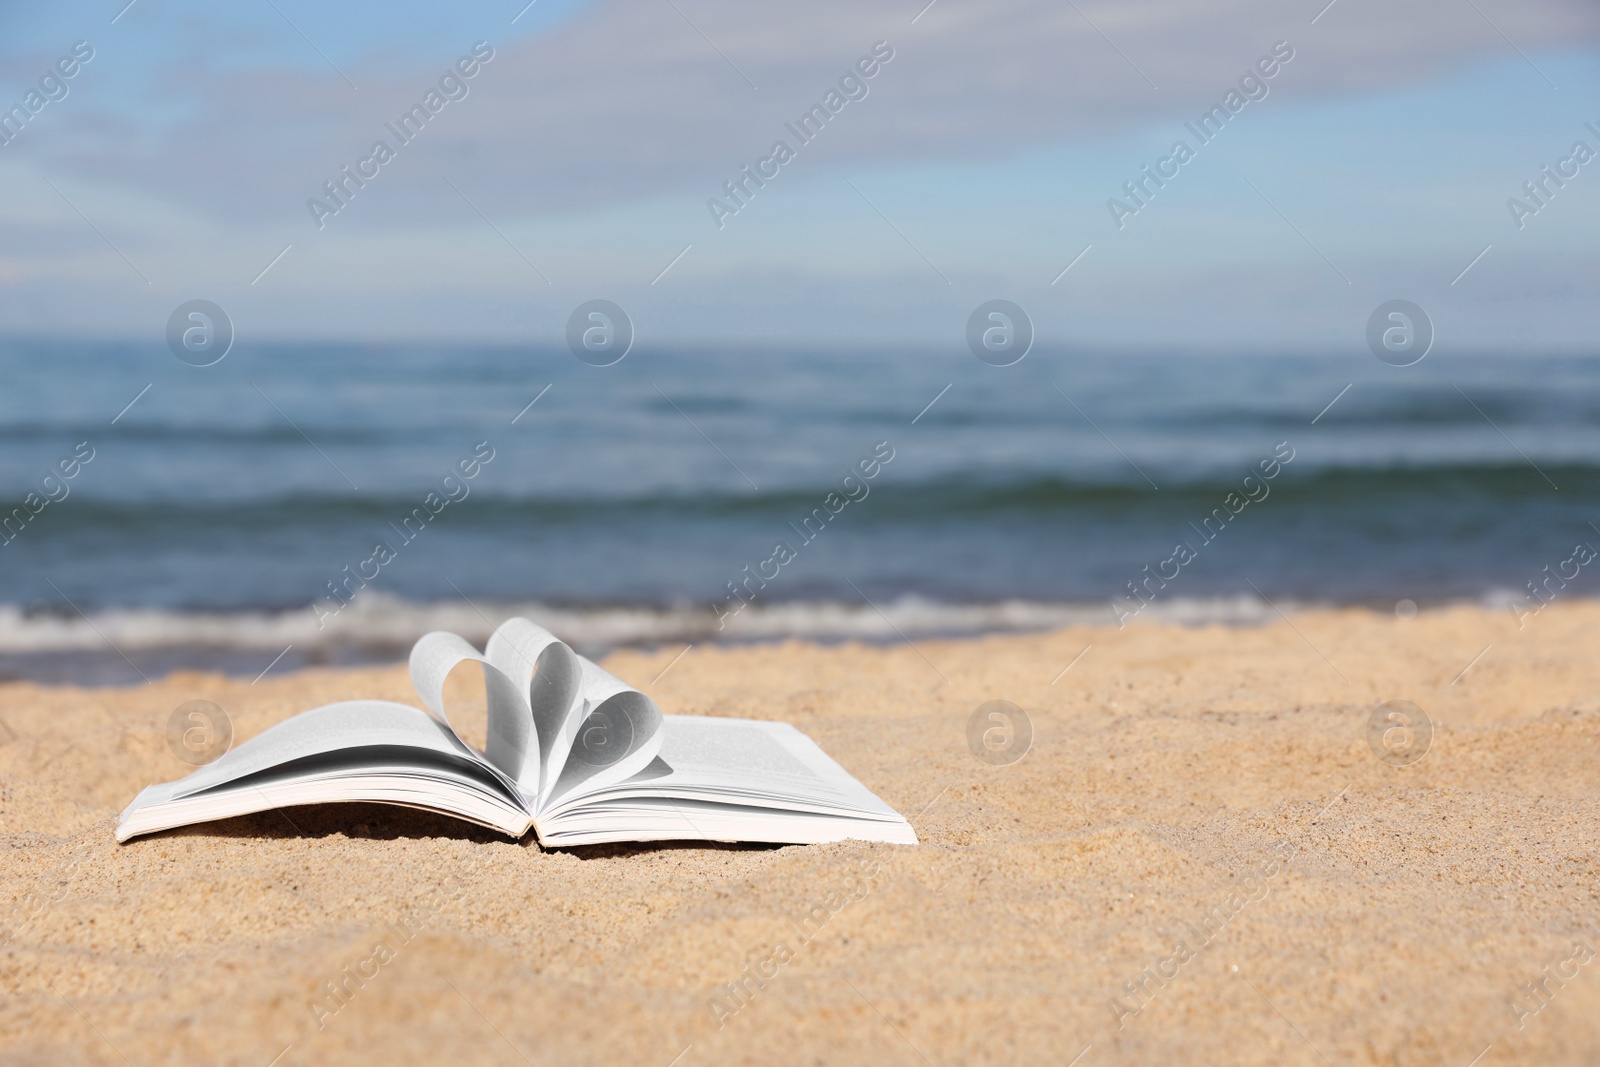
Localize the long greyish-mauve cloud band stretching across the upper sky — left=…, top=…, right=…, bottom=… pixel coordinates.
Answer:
left=15, top=0, right=1600, bottom=227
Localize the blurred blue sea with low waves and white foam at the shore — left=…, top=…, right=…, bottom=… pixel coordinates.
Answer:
left=0, top=338, right=1600, bottom=685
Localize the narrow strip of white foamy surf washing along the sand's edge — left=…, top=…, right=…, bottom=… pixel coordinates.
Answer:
left=0, top=590, right=1548, bottom=688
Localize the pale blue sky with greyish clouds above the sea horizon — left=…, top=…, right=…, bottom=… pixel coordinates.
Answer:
left=0, top=0, right=1600, bottom=352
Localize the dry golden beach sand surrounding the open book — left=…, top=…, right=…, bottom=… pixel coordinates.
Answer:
left=0, top=603, right=1600, bottom=1067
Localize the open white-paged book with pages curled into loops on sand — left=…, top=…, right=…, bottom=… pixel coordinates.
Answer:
left=117, top=619, right=917, bottom=846
